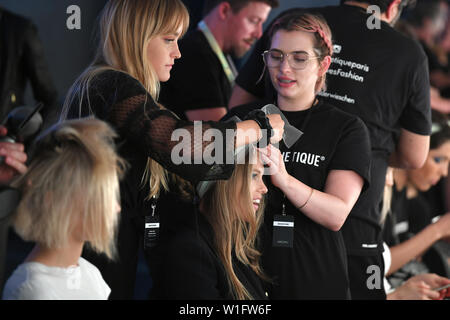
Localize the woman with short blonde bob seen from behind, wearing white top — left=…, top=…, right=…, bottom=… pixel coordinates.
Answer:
left=3, top=119, right=124, bottom=300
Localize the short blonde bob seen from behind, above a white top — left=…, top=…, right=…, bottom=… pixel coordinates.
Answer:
left=13, top=119, right=124, bottom=258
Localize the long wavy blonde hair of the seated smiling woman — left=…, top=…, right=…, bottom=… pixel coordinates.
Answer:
left=202, top=151, right=267, bottom=300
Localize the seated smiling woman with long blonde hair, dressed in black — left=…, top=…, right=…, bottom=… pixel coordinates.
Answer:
left=151, top=148, right=267, bottom=300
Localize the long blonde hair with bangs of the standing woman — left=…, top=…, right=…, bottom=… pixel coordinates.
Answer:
left=61, top=0, right=189, bottom=197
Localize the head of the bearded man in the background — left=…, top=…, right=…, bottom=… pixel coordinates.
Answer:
left=204, top=0, right=278, bottom=58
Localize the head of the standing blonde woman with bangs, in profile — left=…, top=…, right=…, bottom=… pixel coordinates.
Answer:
left=97, top=0, right=189, bottom=99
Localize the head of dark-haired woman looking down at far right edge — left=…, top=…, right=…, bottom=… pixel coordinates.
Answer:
left=407, top=114, right=450, bottom=191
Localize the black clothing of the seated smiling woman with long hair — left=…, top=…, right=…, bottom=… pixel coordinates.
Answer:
left=151, top=212, right=267, bottom=300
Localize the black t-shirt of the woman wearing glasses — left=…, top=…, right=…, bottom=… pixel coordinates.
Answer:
left=224, top=101, right=370, bottom=299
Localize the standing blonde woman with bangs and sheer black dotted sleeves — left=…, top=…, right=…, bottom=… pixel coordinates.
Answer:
left=61, top=0, right=284, bottom=298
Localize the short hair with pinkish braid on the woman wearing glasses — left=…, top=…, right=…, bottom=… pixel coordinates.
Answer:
left=269, top=11, right=333, bottom=93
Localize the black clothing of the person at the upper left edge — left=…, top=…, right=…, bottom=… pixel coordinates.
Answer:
left=0, top=8, right=57, bottom=121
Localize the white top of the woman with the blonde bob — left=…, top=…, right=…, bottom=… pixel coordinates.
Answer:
left=3, top=257, right=111, bottom=300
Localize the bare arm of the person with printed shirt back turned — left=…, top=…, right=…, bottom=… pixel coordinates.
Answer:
left=389, top=129, right=430, bottom=169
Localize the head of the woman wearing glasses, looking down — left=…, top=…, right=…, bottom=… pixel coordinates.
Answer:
left=263, top=13, right=333, bottom=99
